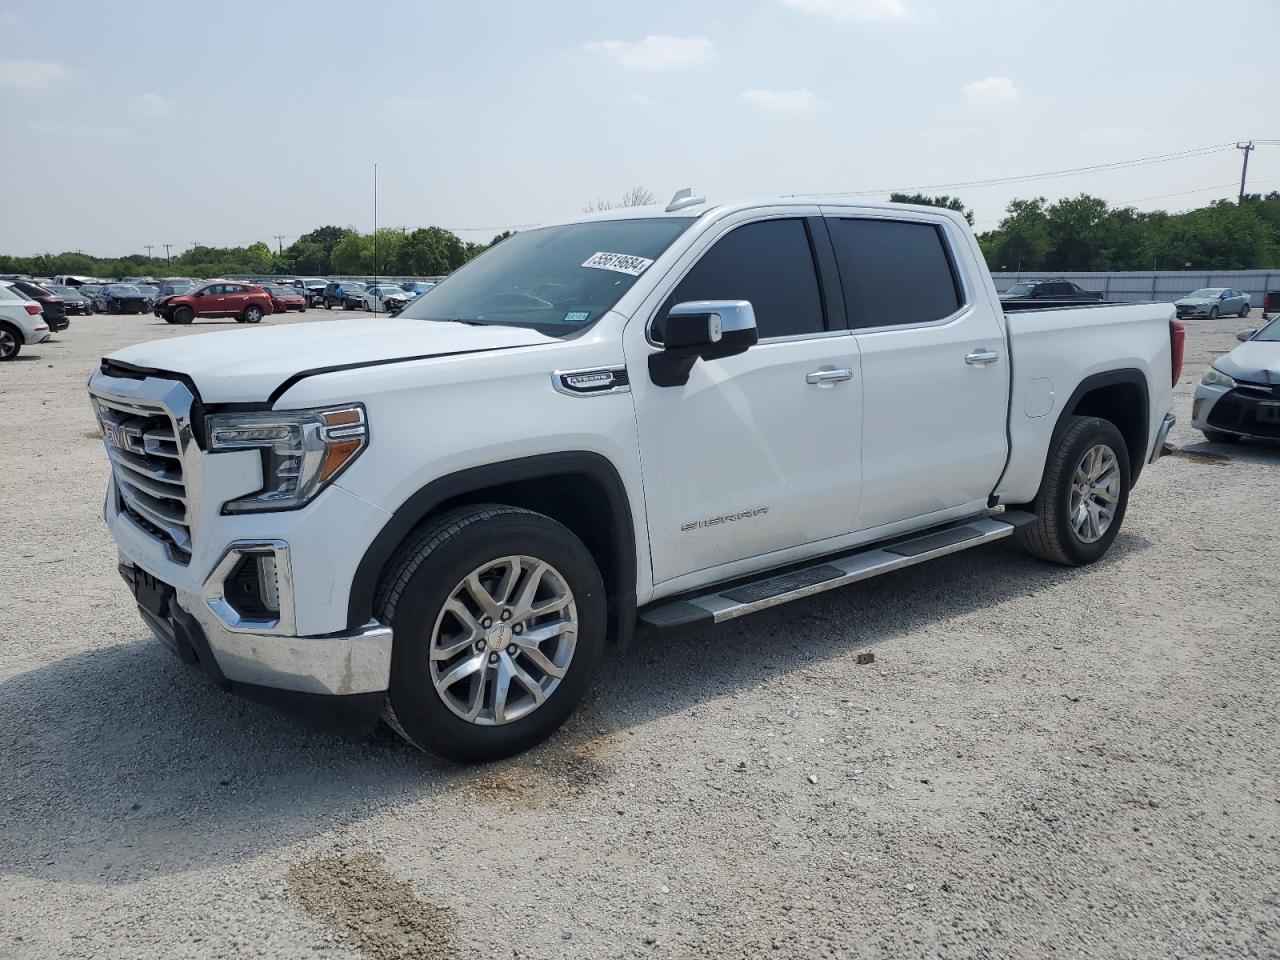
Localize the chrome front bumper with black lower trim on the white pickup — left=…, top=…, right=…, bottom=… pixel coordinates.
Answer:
left=119, top=552, right=392, bottom=732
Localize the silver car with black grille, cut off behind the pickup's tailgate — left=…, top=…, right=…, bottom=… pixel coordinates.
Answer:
left=1192, top=317, right=1280, bottom=443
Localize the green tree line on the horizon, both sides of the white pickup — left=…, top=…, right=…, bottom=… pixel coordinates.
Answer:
left=0, top=188, right=1280, bottom=276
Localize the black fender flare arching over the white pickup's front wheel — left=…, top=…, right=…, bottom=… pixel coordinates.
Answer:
left=347, top=451, right=636, bottom=645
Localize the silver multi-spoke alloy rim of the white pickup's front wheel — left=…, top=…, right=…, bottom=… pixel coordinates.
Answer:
left=430, top=556, right=577, bottom=726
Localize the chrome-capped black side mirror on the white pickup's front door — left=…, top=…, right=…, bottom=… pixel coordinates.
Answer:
left=649, top=300, right=759, bottom=387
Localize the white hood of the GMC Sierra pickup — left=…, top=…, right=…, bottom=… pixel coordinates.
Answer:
left=106, top=317, right=559, bottom=403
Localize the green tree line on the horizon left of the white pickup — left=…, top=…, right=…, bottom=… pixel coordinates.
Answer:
left=0, top=227, right=511, bottom=278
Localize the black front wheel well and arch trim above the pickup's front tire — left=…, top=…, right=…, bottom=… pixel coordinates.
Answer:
left=347, top=452, right=636, bottom=644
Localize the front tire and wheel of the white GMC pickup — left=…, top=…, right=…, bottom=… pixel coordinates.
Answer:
left=375, top=504, right=607, bottom=762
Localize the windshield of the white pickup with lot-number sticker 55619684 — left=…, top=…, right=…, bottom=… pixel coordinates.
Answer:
left=401, top=218, right=692, bottom=337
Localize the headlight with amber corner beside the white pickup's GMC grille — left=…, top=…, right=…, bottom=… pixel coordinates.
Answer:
left=205, top=403, right=369, bottom=513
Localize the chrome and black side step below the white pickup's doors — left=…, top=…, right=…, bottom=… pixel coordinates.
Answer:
left=639, top=511, right=1034, bottom=630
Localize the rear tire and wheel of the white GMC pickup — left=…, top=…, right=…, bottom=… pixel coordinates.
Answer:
left=1018, top=416, right=1132, bottom=567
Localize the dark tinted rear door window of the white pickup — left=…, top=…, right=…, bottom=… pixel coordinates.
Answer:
left=828, top=219, right=961, bottom=328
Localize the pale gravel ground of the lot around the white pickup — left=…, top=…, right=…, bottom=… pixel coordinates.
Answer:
left=0, top=311, right=1280, bottom=960
